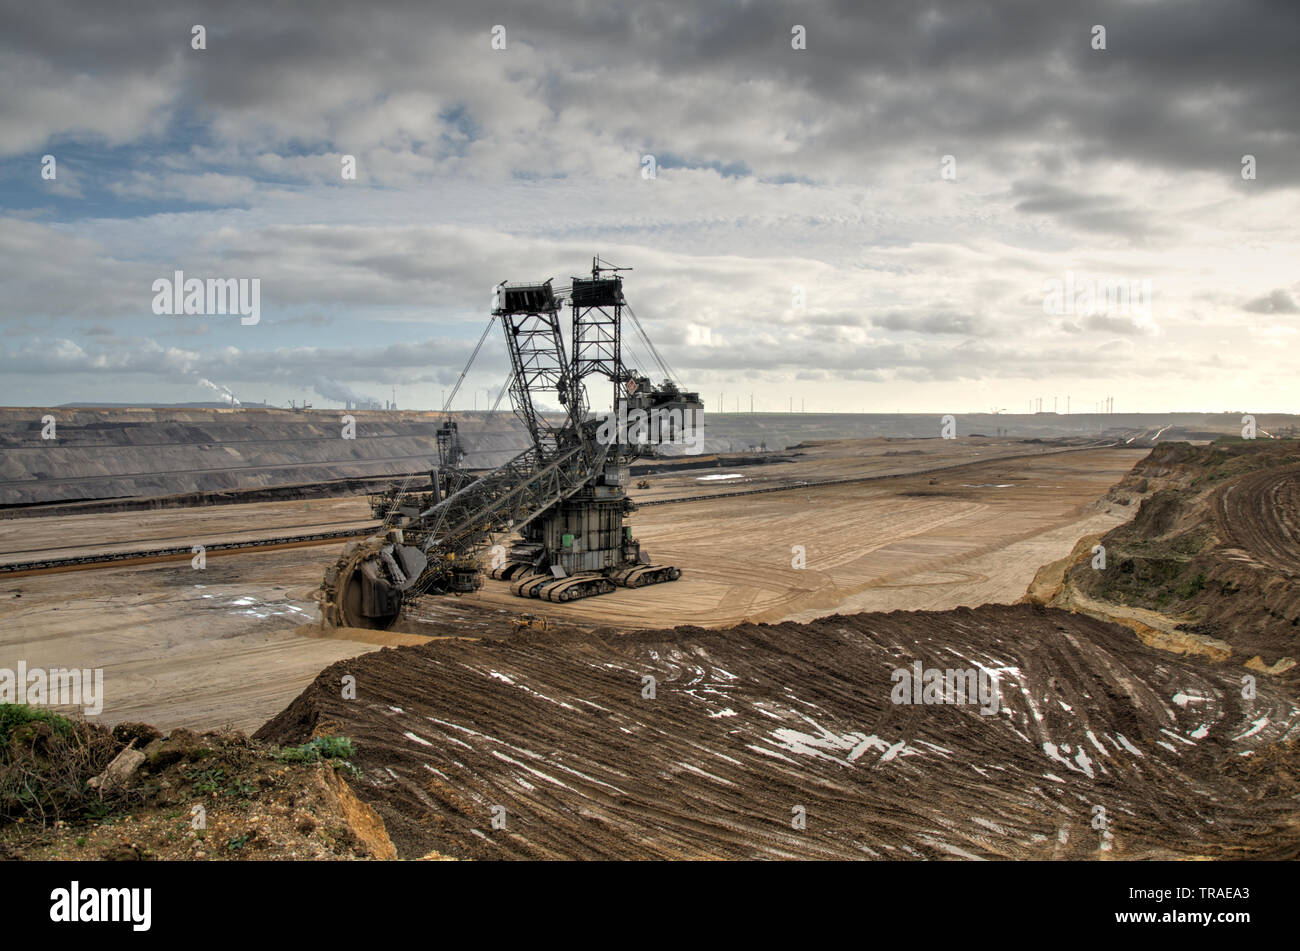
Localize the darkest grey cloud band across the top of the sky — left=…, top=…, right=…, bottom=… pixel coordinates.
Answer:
left=0, top=0, right=1300, bottom=184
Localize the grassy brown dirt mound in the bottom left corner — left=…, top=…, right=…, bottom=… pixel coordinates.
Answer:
left=0, top=707, right=397, bottom=861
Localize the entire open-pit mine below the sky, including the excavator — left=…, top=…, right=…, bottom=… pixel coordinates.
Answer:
left=0, top=260, right=1300, bottom=860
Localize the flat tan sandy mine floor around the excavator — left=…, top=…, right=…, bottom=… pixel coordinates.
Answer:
left=0, top=439, right=1141, bottom=730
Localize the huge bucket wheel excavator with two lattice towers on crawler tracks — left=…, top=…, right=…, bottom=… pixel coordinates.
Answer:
left=317, top=259, right=703, bottom=629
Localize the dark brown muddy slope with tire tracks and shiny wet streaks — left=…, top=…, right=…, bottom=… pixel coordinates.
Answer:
left=257, top=605, right=1300, bottom=859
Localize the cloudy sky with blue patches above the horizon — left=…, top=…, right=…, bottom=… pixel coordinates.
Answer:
left=0, top=0, right=1300, bottom=412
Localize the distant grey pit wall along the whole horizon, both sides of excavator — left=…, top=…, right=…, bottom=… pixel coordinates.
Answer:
left=0, top=407, right=1295, bottom=507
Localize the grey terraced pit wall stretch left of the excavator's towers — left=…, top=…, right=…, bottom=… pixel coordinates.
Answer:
left=0, top=407, right=538, bottom=505
